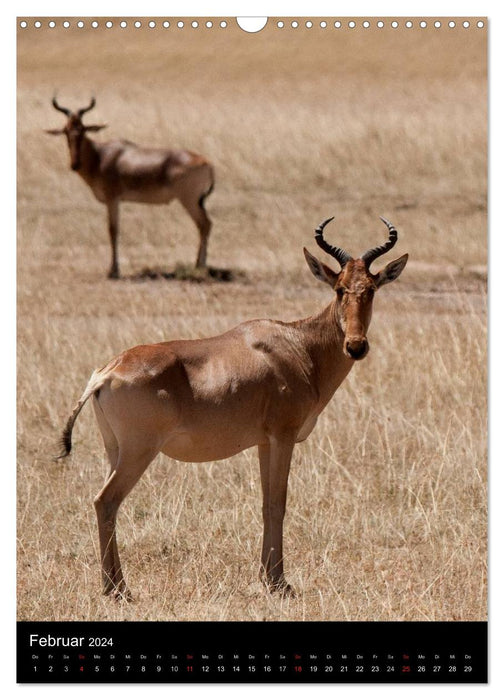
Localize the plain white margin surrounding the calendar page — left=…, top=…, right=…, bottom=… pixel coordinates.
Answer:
left=0, top=0, right=504, bottom=700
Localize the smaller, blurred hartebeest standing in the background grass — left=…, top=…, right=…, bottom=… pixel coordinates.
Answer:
left=47, top=98, right=214, bottom=278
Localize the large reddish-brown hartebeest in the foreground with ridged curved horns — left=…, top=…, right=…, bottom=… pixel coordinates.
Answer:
left=60, top=219, right=408, bottom=598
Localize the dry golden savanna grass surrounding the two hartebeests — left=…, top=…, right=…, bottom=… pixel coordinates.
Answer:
left=17, top=19, right=487, bottom=620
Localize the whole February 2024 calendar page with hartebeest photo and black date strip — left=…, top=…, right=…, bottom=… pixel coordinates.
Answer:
left=16, top=16, right=488, bottom=684
